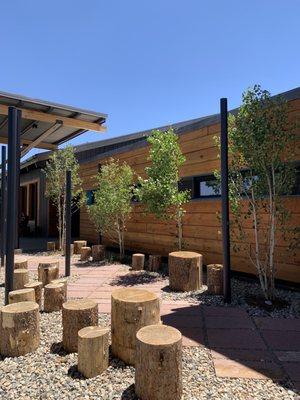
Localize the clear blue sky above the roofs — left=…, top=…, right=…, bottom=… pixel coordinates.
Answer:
left=0, top=0, right=300, bottom=153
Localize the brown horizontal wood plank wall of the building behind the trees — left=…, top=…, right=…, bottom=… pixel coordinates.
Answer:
left=80, top=100, right=300, bottom=283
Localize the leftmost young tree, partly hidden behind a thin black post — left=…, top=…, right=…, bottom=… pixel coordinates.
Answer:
left=44, top=146, right=85, bottom=250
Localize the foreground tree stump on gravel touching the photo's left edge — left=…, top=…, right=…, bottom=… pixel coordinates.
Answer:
left=0, top=301, right=40, bottom=357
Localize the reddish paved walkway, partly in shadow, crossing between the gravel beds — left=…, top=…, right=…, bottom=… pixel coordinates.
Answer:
left=23, top=256, right=300, bottom=389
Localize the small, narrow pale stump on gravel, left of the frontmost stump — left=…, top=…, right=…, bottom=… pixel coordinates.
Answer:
left=78, top=326, right=109, bottom=378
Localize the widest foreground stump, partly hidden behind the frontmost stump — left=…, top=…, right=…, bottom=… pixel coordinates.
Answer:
left=111, top=288, right=160, bottom=365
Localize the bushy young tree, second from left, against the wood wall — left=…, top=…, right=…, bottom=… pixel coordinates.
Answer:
left=88, top=159, right=133, bottom=259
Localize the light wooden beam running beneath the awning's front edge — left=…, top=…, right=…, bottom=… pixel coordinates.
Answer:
left=0, top=104, right=106, bottom=132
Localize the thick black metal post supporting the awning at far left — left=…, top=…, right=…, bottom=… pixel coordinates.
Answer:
left=5, top=107, right=21, bottom=304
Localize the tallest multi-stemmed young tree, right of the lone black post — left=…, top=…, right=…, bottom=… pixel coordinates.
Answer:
left=217, top=85, right=296, bottom=301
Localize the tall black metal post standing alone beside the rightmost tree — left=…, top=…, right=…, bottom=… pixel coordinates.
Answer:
left=220, top=98, right=231, bottom=303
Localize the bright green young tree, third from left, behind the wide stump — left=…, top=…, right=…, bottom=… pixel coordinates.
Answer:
left=136, top=128, right=190, bottom=250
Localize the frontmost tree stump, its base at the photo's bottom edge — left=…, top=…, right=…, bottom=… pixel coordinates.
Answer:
left=135, top=325, right=182, bottom=400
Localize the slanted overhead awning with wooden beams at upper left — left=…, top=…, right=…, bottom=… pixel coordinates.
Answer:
left=0, top=91, right=107, bottom=156
